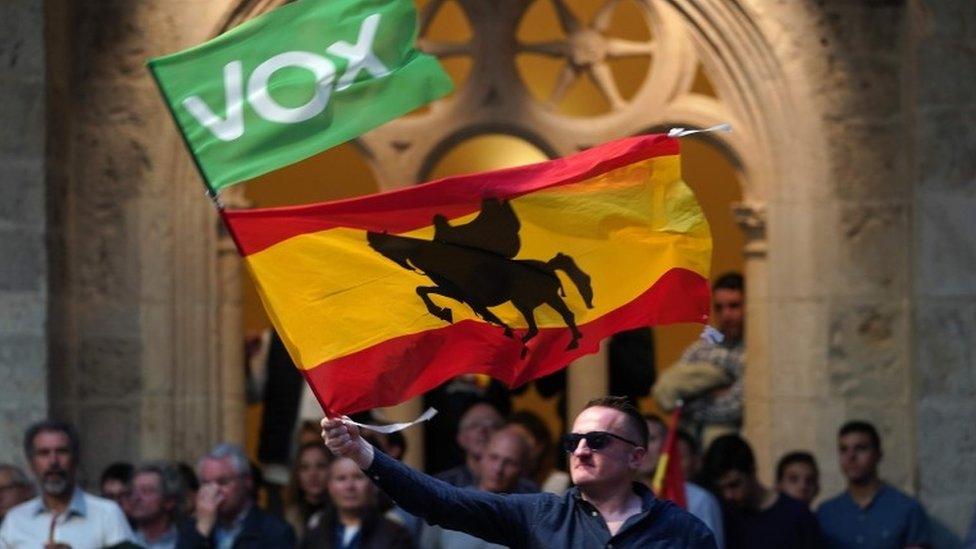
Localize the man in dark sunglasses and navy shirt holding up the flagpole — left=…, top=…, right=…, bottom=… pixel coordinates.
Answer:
left=322, top=397, right=715, bottom=549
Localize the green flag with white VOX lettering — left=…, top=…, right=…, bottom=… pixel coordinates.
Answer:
left=149, top=0, right=452, bottom=192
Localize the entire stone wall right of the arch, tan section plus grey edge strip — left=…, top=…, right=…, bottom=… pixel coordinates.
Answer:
left=747, top=0, right=976, bottom=536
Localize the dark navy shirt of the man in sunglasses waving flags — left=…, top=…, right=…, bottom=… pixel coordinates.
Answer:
left=366, top=450, right=715, bottom=549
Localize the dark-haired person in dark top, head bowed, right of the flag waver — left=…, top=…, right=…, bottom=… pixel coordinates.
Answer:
left=702, top=435, right=823, bottom=549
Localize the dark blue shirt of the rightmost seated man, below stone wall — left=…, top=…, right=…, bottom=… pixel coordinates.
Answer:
left=817, top=484, right=931, bottom=549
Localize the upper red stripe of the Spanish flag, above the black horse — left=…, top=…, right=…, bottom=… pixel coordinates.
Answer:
left=223, top=134, right=678, bottom=255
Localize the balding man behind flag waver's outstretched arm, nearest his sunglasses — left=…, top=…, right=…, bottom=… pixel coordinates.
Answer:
left=420, top=427, right=531, bottom=549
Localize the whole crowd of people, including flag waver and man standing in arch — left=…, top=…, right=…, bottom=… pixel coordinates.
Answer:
left=0, top=274, right=976, bottom=549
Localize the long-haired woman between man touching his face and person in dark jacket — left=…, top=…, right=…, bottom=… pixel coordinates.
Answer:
left=285, top=438, right=332, bottom=537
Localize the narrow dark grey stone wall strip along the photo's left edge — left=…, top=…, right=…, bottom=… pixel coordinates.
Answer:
left=0, top=0, right=48, bottom=464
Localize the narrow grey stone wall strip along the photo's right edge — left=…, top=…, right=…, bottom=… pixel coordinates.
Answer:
left=908, top=0, right=976, bottom=532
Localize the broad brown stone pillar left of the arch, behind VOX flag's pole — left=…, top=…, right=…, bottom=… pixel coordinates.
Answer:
left=47, top=0, right=243, bottom=478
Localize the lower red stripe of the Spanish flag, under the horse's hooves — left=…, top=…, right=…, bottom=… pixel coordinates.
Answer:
left=303, top=268, right=709, bottom=414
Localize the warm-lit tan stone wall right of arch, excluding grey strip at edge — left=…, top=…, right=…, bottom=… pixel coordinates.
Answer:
left=746, top=0, right=916, bottom=495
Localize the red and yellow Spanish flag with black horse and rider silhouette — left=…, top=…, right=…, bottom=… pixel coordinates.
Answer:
left=222, top=135, right=712, bottom=414
